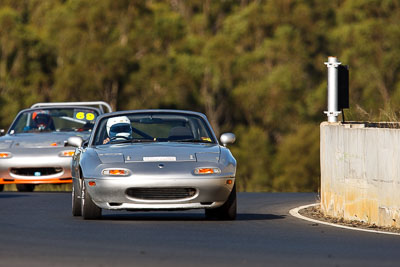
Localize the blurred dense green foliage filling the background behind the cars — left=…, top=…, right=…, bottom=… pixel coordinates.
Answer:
left=0, top=0, right=400, bottom=191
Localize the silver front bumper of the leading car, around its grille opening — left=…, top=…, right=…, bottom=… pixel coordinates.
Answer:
left=85, top=177, right=235, bottom=213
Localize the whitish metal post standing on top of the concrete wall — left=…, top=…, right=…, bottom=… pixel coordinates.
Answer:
left=324, top=57, right=342, bottom=122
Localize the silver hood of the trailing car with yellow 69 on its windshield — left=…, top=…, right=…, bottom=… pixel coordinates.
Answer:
left=0, top=132, right=89, bottom=149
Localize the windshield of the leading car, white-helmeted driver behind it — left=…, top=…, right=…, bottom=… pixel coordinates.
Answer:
left=93, top=113, right=216, bottom=145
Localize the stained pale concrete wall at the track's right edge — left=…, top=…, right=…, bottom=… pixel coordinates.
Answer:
left=320, top=122, right=400, bottom=227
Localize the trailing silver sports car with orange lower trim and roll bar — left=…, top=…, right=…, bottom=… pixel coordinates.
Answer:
left=0, top=101, right=111, bottom=192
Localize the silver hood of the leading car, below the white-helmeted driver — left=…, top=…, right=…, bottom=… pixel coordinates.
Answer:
left=96, top=142, right=220, bottom=163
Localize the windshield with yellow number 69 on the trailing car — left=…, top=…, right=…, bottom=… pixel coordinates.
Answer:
left=9, top=107, right=99, bottom=134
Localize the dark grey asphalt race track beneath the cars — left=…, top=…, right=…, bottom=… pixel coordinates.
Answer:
left=0, top=192, right=400, bottom=267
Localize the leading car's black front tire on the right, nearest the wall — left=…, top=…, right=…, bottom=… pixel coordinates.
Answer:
left=205, top=184, right=237, bottom=221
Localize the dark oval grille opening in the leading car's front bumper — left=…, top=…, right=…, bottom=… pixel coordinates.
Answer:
left=126, top=187, right=196, bottom=200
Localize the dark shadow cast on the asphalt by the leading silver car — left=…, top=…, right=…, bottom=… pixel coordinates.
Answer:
left=102, top=213, right=286, bottom=221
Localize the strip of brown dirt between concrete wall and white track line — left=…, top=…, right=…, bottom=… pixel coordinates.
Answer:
left=299, top=205, right=400, bottom=234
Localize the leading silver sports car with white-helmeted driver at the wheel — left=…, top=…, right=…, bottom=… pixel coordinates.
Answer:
left=68, top=110, right=236, bottom=220
